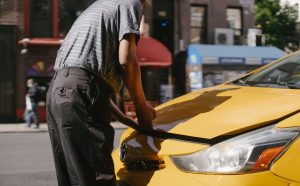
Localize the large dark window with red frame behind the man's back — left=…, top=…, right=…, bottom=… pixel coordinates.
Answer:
left=27, top=0, right=95, bottom=38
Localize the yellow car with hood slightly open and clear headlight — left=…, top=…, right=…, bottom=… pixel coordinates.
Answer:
left=113, top=53, right=300, bottom=186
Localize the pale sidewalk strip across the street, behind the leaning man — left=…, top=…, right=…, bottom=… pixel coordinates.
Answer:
left=0, top=121, right=127, bottom=133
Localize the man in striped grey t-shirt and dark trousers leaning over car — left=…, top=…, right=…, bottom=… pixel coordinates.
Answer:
left=47, top=0, right=155, bottom=186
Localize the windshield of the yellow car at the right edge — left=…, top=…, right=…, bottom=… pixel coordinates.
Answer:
left=233, top=55, right=300, bottom=89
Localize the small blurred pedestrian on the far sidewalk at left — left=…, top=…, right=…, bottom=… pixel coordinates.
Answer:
left=24, top=78, right=40, bottom=128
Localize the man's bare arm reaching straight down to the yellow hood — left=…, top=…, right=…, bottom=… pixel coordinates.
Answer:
left=119, top=34, right=155, bottom=131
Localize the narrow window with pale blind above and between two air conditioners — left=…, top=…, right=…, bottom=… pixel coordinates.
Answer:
left=227, top=8, right=242, bottom=44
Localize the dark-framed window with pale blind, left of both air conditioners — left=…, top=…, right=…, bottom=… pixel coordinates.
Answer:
left=190, top=5, right=206, bottom=43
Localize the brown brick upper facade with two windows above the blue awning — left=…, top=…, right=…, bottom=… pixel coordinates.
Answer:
left=151, top=0, right=254, bottom=54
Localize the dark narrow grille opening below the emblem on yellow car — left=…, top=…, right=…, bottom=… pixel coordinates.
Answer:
left=124, top=160, right=166, bottom=171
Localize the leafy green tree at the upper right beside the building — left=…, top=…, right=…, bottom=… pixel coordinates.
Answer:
left=255, top=0, right=297, bottom=49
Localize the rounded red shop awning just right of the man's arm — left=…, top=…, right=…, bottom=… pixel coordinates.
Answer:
left=136, top=37, right=172, bottom=67
